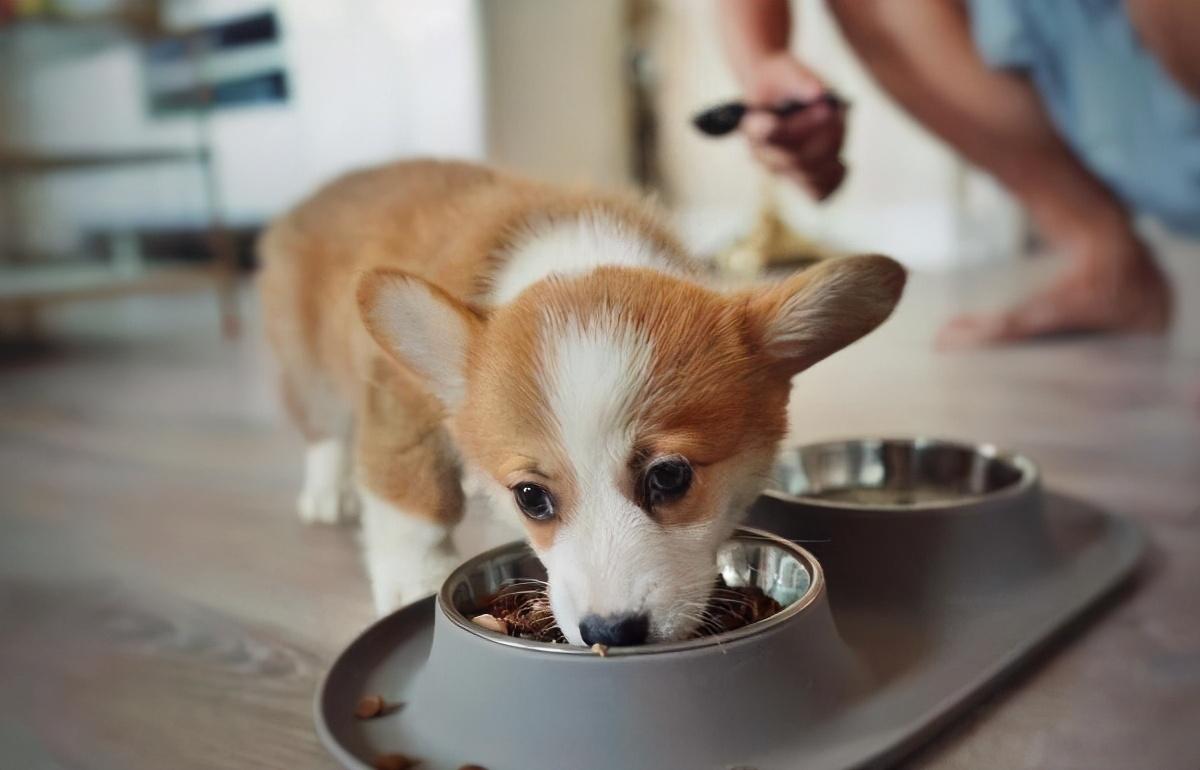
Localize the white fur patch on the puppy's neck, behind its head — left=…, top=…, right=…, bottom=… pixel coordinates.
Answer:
left=491, top=213, right=678, bottom=303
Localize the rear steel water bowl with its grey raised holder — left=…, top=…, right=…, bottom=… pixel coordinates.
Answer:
left=748, top=438, right=1051, bottom=607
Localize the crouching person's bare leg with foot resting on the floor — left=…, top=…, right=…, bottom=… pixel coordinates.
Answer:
left=830, top=0, right=1170, bottom=345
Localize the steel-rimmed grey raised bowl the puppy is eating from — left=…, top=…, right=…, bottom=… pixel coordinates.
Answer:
left=396, top=529, right=865, bottom=770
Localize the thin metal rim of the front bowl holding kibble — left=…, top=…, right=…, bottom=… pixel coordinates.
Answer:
left=437, top=527, right=824, bottom=660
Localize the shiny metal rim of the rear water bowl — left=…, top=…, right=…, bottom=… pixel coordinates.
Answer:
left=763, top=435, right=1042, bottom=513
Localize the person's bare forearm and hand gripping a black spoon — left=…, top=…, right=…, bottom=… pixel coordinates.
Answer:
left=718, top=0, right=846, bottom=200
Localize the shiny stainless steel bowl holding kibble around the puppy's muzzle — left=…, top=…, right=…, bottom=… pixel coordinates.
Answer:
left=438, top=529, right=823, bottom=656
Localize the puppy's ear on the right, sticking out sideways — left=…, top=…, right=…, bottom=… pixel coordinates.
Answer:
left=746, top=254, right=905, bottom=375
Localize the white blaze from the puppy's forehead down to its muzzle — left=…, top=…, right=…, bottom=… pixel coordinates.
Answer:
left=539, top=311, right=710, bottom=644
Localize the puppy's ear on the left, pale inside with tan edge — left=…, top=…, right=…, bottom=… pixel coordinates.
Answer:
left=358, top=267, right=484, bottom=409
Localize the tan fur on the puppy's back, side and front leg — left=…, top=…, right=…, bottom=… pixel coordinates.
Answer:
left=259, top=155, right=684, bottom=524
